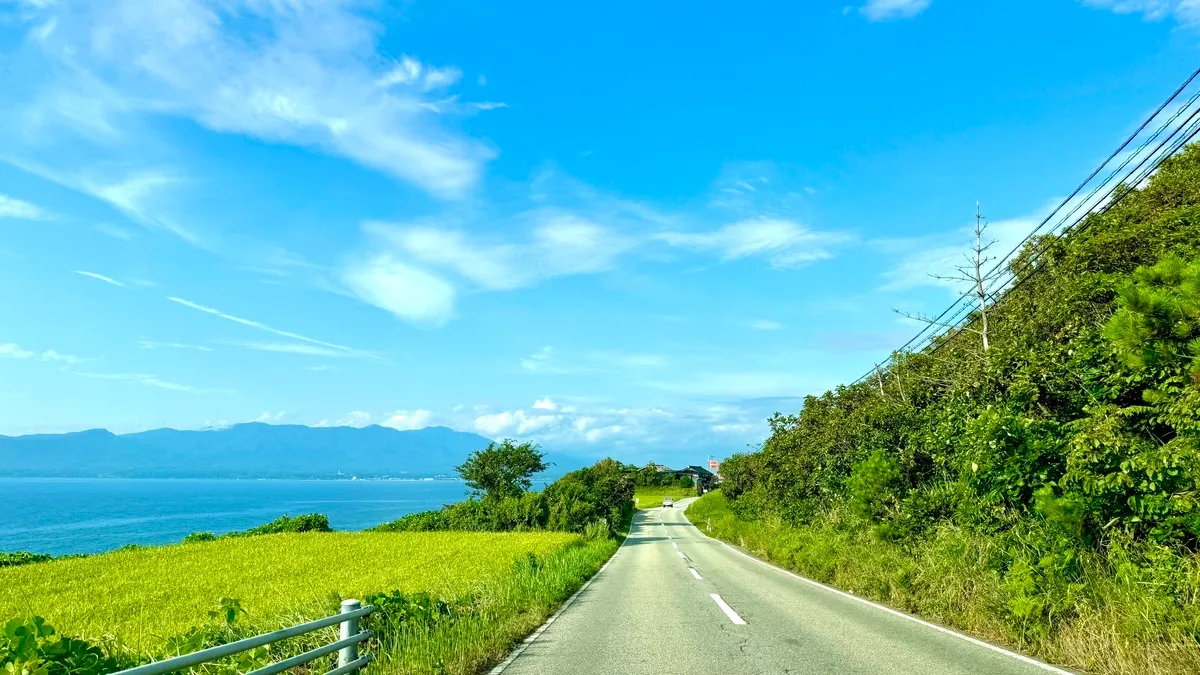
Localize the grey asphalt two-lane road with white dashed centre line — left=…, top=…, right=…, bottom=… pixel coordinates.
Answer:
left=493, top=503, right=1064, bottom=675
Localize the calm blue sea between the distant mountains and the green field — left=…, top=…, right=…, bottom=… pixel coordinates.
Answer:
left=0, top=478, right=467, bottom=555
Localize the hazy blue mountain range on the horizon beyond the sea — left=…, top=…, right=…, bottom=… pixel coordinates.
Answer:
left=0, top=423, right=583, bottom=478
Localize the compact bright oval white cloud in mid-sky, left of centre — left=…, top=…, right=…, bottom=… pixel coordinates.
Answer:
left=342, top=253, right=455, bottom=325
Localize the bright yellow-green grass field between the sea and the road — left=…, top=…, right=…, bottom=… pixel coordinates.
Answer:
left=0, top=532, right=617, bottom=674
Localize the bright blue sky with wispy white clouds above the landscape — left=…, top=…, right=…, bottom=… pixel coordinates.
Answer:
left=0, top=0, right=1200, bottom=461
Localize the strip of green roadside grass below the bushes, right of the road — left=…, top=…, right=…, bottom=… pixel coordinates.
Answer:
left=686, top=490, right=1200, bottom=675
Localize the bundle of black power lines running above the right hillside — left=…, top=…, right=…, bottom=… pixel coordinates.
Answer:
left=853, top=68, right=1200, bottom=384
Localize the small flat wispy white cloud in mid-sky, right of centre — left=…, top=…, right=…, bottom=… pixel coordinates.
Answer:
left=655, top=217, right=850, bottom=268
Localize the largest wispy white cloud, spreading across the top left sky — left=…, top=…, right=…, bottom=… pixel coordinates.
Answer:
left=8, top=0, right=493, bottom=198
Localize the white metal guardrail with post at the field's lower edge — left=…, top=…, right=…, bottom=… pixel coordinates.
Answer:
left=114, top=601, right=374, bottom=675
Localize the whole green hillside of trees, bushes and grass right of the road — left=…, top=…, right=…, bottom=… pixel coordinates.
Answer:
left=710, top=147, right=1200, bottom=674
